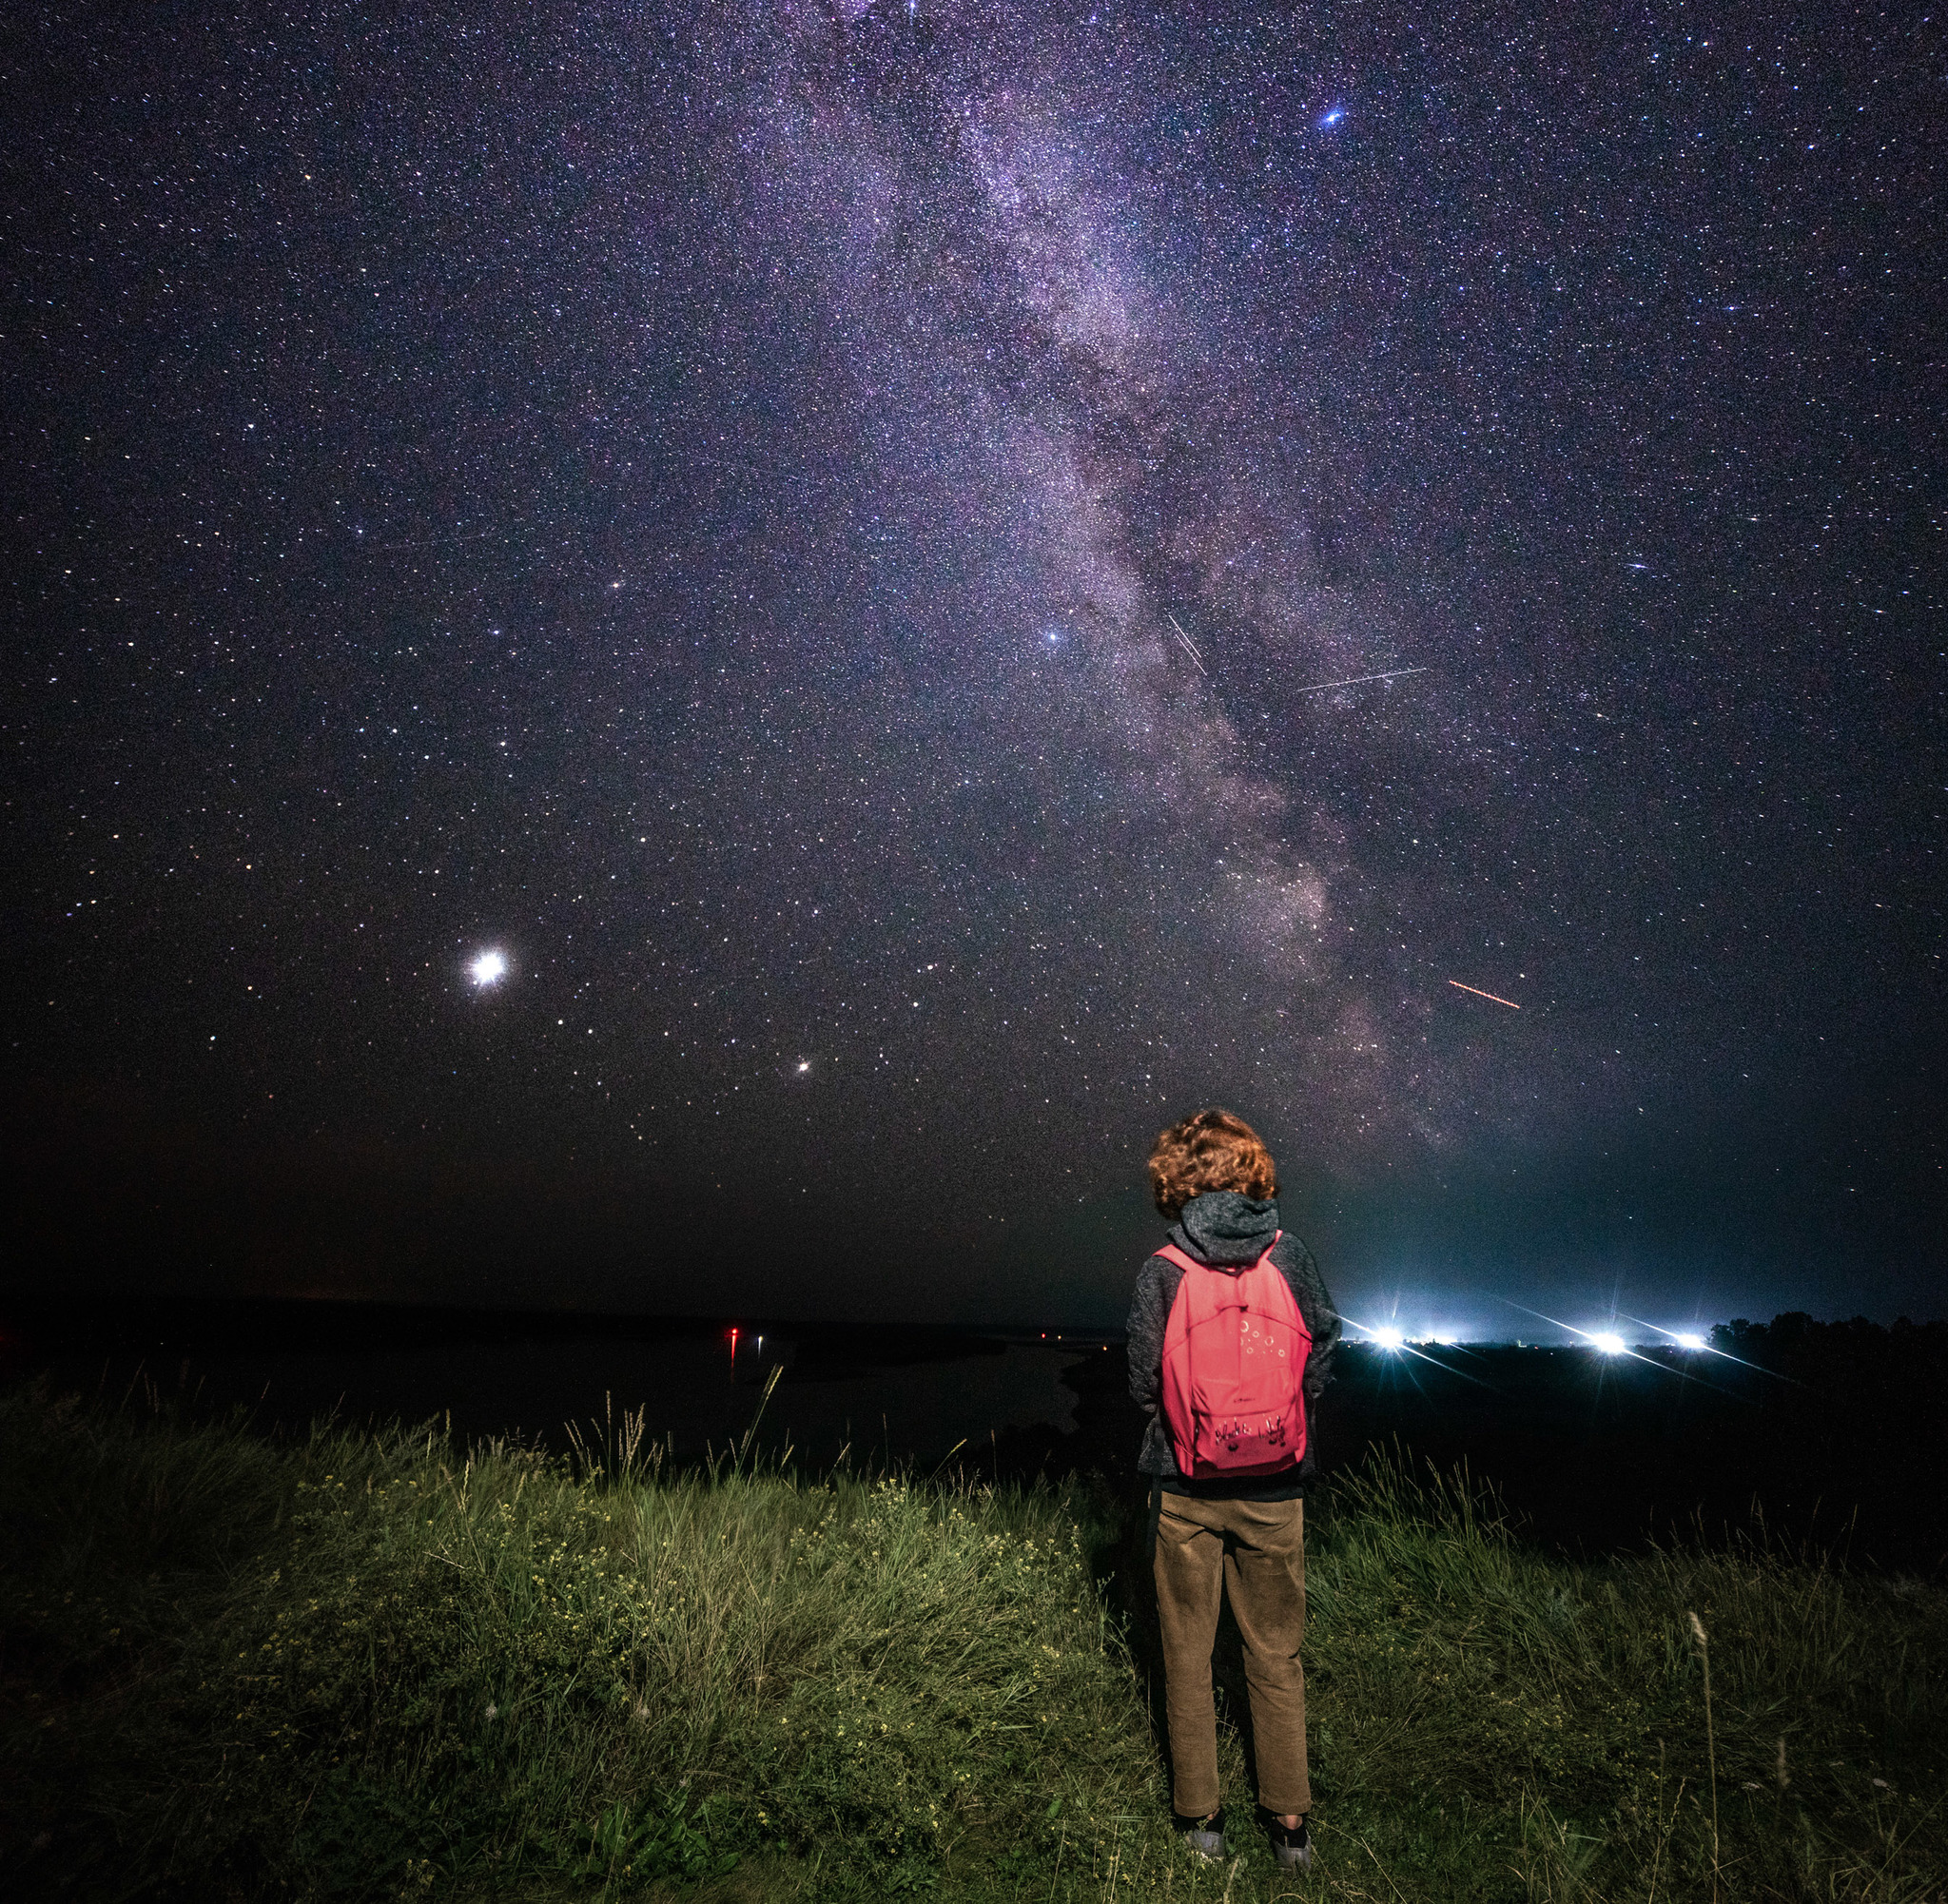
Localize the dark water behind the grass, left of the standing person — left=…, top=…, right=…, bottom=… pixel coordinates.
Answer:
left=0, top=1302, right=1104, bottom=1467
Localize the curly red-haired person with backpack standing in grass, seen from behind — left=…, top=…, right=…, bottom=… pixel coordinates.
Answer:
left=1130, top=1110, right=1340, bottom=1869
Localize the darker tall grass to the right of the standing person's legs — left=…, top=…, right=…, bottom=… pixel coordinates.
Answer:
left=1285, top=1460, right=1948, bottom=1900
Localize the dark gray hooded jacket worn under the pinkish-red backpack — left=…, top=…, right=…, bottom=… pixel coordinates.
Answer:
left=1130, top=1190, right=1340, bottom=1501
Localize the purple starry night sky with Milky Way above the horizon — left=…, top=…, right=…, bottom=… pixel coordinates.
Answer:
left=0, top=0, right=1948, bottom=1333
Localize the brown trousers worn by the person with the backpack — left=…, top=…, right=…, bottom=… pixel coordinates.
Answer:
left=1155, top=1491, right=1313, bottom=1818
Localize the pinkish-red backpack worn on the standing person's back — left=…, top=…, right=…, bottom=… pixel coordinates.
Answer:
left=1158, top=1233, right=1313, bottom=1482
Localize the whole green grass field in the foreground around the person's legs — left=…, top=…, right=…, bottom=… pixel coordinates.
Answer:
left=0, top=1390, right=1948, bottom=1904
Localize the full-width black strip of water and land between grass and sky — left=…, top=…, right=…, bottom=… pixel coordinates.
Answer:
left=0, top=1298, right=1948, bottom=1577
